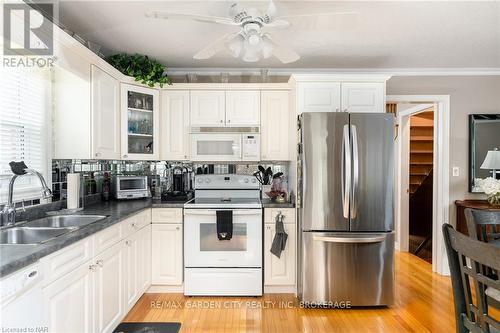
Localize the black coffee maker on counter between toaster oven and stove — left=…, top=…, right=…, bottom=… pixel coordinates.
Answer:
left=161, top=165, right=193, bottom=202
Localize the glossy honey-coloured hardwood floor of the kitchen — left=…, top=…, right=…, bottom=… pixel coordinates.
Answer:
left=124, top=253, right=455, bottom=333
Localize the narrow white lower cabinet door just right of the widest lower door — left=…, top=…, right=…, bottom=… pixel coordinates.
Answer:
left=94, top=242, right=125, bottom=333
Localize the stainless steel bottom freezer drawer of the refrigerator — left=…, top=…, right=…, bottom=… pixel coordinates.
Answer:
left=299, top=232, right=394, bottom=306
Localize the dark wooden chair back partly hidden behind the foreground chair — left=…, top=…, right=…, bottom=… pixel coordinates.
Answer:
left=464, top=208, right=500, bottom=245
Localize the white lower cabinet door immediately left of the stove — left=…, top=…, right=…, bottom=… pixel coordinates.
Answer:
left=151, top=223, right=183, bottom=285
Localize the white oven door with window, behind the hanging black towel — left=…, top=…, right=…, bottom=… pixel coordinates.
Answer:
left=184, top=209, right=262, bottom=267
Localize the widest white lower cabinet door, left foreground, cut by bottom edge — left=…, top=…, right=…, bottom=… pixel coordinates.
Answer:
left=42, top=261, right=94, bottom=333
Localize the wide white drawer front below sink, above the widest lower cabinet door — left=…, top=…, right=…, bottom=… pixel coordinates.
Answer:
left=41, top=237, right=94, bottom=285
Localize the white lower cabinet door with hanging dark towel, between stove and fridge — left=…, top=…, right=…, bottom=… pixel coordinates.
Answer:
left=264, top=218, right=297, bottom=286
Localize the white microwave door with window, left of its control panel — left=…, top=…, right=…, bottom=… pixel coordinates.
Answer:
left=191, top=133, right=241, bottom=161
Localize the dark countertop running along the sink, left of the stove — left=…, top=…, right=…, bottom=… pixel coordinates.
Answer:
left=0, top=199, right=152, bottom=277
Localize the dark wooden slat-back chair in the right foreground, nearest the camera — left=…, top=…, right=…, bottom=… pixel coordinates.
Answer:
left=443, top=224, right=500, bottom=333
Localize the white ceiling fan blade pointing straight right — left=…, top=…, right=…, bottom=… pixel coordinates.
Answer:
left=272, top=12, right=359, bottom=30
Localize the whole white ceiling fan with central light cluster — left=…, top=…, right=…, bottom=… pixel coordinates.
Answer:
left=146, top=0, right=357, bottom=64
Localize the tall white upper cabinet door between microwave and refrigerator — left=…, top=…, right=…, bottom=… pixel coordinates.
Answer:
left=260, top=91, right=290, bottom=161
